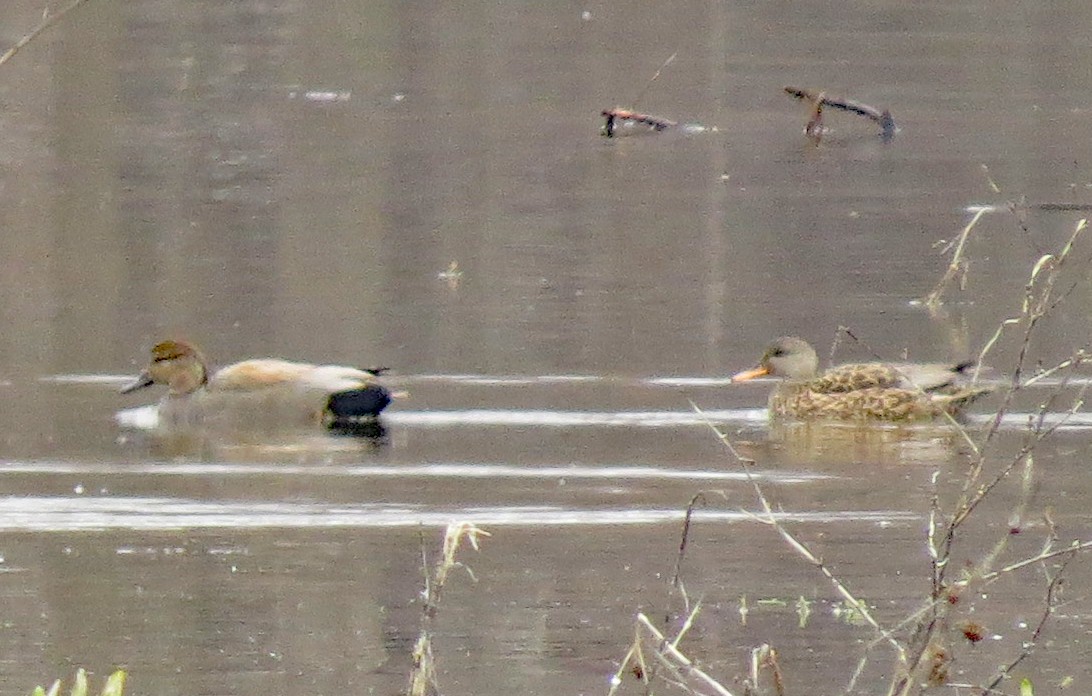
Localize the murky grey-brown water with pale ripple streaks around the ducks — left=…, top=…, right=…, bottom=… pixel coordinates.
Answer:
left=0, top=0, right=1092, bottom=695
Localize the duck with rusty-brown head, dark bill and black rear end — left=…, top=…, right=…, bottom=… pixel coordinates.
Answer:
left=121, top=340, right=391, bottom=428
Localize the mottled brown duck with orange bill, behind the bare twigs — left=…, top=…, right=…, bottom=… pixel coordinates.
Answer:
left=732, top=337, right=990, bottom=422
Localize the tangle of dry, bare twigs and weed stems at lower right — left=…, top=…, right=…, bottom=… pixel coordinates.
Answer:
left=607, top=213, right=1092, bottom=696
